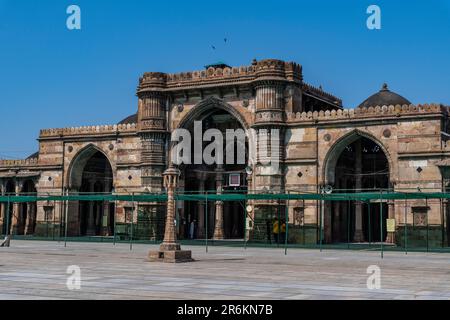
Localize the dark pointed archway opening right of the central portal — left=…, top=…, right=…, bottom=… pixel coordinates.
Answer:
left=324, top=134, right=391, bottom=242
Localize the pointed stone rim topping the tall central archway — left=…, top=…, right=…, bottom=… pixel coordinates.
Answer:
left=178, top=97, right=250, bottom=131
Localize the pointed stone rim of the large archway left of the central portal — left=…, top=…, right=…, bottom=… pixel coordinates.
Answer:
left=66, top=143, right=116, bottom=189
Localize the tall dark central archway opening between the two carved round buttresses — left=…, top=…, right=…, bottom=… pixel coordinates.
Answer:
left=177, top=98, right=248, bottom=240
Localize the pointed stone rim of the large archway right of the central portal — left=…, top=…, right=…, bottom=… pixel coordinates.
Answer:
left=322, top=129, right=394, bottom=185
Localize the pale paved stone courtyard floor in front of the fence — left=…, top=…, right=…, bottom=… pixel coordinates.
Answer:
left=0, top=240, right=450, bottom=299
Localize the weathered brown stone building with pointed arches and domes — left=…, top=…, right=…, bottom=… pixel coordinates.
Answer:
left=0, top=60, right=450, bottom=245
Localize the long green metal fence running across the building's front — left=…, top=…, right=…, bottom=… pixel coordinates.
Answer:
left=0, top=189, right=450, bottom=256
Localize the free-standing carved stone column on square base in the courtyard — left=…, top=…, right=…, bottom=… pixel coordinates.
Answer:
left=148, top=166, right=192, bottom=262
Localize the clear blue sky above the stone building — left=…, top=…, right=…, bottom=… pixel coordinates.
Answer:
left=0, top=0, right=450, bottom=158
